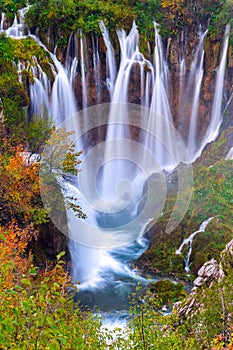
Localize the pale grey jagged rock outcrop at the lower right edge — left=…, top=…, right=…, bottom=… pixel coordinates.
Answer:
left=176, top=240, right=233, bottom=318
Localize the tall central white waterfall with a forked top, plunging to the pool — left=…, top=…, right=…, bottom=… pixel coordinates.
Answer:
left=102, top=23, right=153, bottom=200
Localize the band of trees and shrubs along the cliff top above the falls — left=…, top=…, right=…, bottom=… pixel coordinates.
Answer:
left=0, top=0, right=233, bottom=45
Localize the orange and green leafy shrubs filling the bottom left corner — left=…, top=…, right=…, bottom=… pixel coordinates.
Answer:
left=0, top=226, right=104, bottom=350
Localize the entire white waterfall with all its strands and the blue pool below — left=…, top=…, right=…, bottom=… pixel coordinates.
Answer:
left=1, top=11, right=229, bottom=322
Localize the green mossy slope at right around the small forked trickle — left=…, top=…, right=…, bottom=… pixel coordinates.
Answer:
left=139, top=160, right=233, bottom=278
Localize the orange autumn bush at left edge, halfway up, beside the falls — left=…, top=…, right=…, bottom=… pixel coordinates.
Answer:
left=0, top=146, right=47, bottom=225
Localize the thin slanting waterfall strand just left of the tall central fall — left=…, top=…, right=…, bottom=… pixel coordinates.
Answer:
left=100, top=21, right=116, bottom=97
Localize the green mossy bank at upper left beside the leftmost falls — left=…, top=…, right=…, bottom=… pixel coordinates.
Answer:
left=0, top=34, right=49, bottom=139
